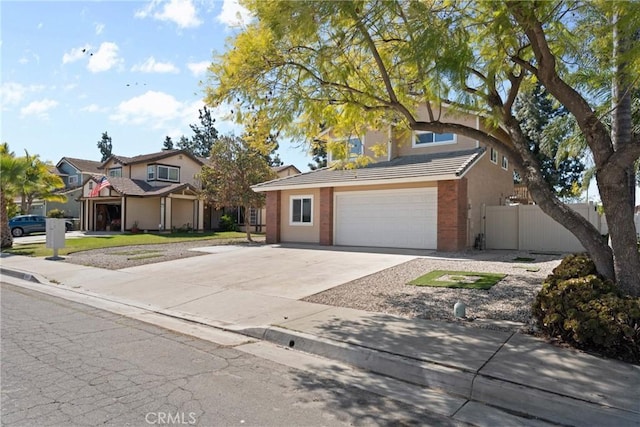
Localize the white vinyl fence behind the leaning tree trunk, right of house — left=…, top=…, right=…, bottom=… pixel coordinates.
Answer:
left=485, top=203, right=606, bottom=252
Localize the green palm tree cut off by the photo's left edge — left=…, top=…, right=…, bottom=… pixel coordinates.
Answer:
left=0, top=142, right=27, bottom=249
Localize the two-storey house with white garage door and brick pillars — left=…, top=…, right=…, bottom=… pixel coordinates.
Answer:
left=253, top=108, right=514, bottom=251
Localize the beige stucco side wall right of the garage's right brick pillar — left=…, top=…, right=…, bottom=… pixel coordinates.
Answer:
left=465, top=149, right=513, bottom=246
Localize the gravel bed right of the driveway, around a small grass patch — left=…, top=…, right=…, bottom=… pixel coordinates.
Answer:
left=304, top=251, right=562, bottom=330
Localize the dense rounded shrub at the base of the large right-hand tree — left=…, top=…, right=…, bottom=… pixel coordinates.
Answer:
left=532, top=255, right=640, bottom=363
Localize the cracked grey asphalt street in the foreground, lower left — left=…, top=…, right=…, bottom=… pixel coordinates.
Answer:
left=0, top=283, right=464, bottom=426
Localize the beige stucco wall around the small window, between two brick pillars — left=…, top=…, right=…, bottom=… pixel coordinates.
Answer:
left=280, top=188, right=320, bottom=243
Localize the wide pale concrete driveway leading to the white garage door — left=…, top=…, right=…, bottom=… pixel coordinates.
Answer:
left=27, top=245, right=417, bottom=329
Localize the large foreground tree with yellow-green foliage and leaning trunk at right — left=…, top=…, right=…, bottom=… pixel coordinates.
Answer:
left=207, top=0, right=640, bottom=295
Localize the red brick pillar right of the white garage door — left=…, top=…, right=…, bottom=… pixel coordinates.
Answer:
left=438, top=178, right=468, bottom=252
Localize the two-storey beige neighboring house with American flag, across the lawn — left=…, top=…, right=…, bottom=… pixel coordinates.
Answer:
left=81, top=150, right=206, bottom=231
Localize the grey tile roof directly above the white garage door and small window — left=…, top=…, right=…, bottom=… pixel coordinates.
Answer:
left=252, top=148, right=485, bottom=191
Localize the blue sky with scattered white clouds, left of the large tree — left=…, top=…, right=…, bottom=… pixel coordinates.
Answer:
left=0, top=0, right=311, bottom=171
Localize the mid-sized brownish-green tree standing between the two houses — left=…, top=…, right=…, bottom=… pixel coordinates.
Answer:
left=198, top=136, right=275, bottom=241
